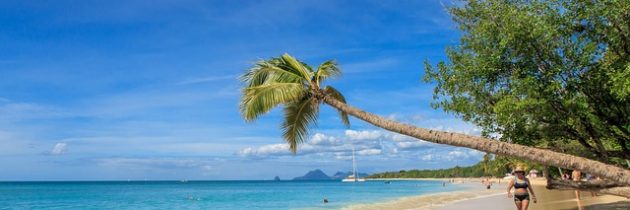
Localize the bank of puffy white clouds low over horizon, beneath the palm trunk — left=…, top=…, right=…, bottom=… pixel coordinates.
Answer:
left=236, top=124, right=483, bottom=162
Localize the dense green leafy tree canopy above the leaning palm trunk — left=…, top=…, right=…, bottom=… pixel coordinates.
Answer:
left=424, top=0, right=630, bottom=163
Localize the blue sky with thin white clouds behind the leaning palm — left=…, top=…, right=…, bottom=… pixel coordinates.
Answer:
left=0, top=0, right=482, bottom=180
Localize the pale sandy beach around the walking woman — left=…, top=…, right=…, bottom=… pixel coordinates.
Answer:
left=347, top=179, right=630, bottom=210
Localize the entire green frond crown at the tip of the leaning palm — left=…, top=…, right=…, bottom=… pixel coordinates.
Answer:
left=240, top=54, right=350, bottom=153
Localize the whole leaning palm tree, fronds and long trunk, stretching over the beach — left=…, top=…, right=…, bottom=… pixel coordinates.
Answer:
left=240, top=54, right=630, bottom=190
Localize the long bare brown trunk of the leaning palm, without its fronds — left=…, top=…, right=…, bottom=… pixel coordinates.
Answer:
left=323, top=95, right=630, bottom=190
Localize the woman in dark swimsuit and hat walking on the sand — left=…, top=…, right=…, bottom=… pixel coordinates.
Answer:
left=508, top=167, right=536, bottom=210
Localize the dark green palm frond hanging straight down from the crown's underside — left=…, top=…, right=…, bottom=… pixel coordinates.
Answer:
left=282, top=96, right=319, bottom=153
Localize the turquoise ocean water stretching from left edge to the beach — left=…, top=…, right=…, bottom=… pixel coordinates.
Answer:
left=0, top=181, right=463, bottom=210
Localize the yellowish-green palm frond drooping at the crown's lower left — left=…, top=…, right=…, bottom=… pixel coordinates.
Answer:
left=240, top=82, right=307, bottom=121
